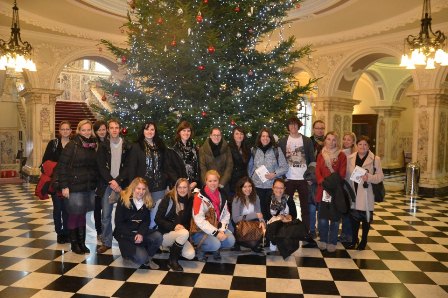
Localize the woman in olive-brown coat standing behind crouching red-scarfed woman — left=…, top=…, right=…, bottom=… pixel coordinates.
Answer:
left=199, top=127, right=233, bottom=193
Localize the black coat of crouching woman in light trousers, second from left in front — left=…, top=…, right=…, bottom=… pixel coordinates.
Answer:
left=155, top=195, right=193, bottom=234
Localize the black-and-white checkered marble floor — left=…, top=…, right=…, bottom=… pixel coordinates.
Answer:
left=0, top=185, right=448, bottom=298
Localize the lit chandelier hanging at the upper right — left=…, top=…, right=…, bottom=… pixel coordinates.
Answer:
left=400, top=0, right=448, bottom=69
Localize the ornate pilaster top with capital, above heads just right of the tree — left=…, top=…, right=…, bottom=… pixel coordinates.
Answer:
left=312, top=97, right=361, bottom=136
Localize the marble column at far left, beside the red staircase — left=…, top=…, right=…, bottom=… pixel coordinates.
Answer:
left=19, top=88, right=62, bottom=176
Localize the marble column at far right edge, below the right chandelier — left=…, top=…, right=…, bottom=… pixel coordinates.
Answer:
left=407, top=89, right=448, bottom=195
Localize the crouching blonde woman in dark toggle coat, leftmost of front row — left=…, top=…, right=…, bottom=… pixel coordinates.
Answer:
left=114, top=177, right=162, bottom=269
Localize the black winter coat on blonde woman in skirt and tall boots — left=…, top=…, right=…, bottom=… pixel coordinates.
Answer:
left=57, top=135, right=98, bottom=193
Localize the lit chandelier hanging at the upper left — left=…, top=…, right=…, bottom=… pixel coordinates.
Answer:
left=0, top=0, right=36, bottom=72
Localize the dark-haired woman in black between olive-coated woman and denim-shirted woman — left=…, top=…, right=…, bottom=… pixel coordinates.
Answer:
left=229, top=126, right=250, bottom=194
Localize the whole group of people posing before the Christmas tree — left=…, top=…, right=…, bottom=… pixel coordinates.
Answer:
left=42, top=117, right=382, bottom=271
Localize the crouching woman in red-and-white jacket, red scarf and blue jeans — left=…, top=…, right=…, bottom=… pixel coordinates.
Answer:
left=190, top=170, right=235, bottom=262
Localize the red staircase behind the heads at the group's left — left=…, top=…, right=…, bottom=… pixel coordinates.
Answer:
left=55, top=101, right=96, bottom=133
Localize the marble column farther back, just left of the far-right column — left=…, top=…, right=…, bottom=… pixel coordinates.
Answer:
left=372, top=106, right=406, bottom=170
